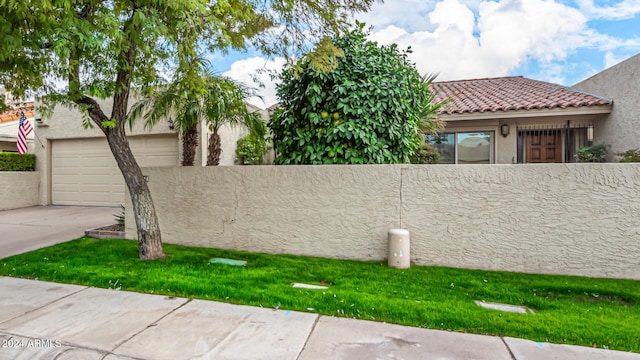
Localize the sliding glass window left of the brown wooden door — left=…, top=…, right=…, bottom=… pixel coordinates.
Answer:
left=426, top=131, right=493, bottom=164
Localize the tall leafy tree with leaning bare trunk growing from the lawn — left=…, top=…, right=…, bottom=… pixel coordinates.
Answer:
left=0, top=0, right=374, bottom=259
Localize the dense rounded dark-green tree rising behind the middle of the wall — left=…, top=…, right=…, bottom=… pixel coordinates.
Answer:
left=269, top=24, right=442, bottom=164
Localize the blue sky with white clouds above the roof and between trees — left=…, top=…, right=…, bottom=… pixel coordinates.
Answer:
left=214, top=0, right=640, bottom=108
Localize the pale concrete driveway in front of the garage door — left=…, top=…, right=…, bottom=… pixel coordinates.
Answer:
left=0, top=206, right=119, bottom=259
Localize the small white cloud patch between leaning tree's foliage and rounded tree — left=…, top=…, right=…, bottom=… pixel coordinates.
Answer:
left=222, top=57, right=285, bottom=109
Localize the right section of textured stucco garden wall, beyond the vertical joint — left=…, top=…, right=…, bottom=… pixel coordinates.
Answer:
left=402, top=164, right=640, bottom=278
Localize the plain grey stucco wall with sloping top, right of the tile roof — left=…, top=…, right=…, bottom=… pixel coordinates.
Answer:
left=572, top=54, right=640, bottom=160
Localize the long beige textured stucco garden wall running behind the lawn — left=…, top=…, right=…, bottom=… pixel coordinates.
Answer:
left=126, top=164, right=640, bottom=279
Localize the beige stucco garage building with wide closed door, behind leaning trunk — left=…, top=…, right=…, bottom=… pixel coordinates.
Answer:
left=35, top=100, right=266, bottom=206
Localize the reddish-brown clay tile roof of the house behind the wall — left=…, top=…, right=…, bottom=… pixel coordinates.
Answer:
left=431, top=76, right=612, bottom=114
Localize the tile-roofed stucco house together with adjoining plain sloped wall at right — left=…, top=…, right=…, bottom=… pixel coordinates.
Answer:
left=427, top=54, right=640, bottom=164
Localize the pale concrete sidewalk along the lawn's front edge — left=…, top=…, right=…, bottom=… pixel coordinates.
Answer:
left=0, top=278, right=640, bottom=360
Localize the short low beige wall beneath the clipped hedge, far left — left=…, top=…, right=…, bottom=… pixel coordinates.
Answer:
left=0, top=171, right=40, bottom=210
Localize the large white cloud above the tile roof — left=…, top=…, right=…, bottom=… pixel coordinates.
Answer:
left=364, top=0, right=593, bottom=80
